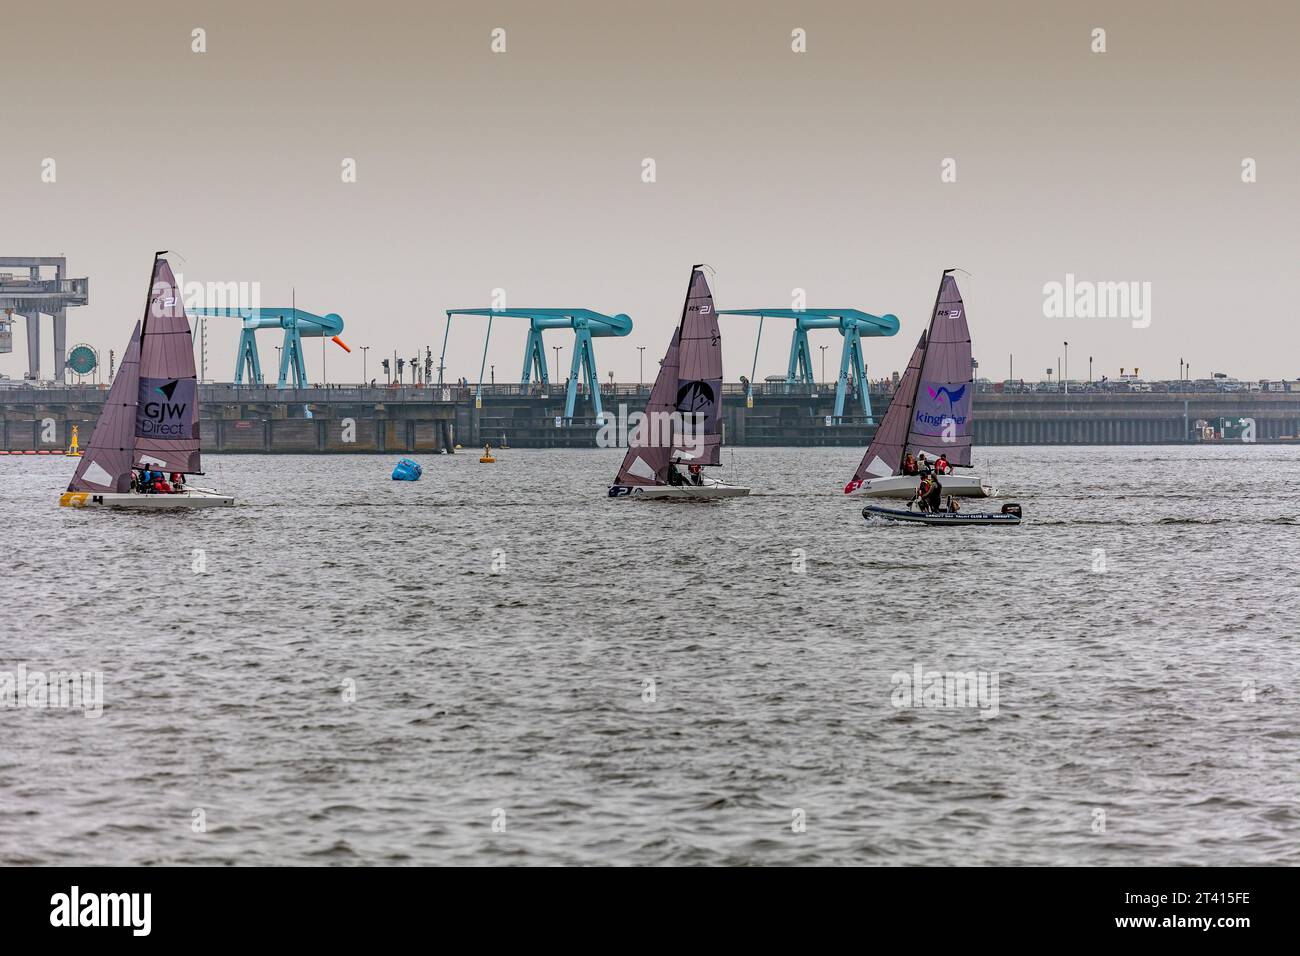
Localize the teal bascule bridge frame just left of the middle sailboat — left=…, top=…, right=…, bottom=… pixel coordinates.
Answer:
left=438, top=308, right=632, bottom=420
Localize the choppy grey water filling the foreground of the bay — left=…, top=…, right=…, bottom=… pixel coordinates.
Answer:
left=0, top=446, right=1300, bottom=864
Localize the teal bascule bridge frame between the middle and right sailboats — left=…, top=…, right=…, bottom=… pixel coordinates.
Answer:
left=718, top=308, right=898, bottom=424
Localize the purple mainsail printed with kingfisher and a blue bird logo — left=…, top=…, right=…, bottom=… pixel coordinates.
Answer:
left=907, top=272, right=975, bottom=466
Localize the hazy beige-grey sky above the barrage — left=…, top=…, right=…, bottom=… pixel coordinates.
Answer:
left=0, top=0, right=1300, bottom=382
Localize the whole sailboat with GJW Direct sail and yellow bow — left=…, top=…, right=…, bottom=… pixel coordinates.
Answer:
left=59, top=252, right=235, bottom=510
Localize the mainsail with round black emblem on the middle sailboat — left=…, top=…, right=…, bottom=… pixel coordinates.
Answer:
left=673, top=265, right=723, bottom=464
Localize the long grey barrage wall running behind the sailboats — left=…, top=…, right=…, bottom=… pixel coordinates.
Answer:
left=0, top=382, right=1300, bottom=454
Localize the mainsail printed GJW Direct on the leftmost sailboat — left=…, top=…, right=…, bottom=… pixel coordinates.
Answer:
left=134, top=254, right=203, bottom=475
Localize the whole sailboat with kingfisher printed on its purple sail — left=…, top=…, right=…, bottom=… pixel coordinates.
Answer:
left=844, top=269, right=993, bottom=498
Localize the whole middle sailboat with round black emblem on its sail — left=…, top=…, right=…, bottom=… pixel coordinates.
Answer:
left=610, top=265, right=749, bottom=501
